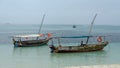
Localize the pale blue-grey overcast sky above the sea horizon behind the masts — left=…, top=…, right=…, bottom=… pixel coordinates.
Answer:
left=0, top=0, right=120, bottom=25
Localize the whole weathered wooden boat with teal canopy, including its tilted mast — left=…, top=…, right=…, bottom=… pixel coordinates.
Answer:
left=50, top=14, right=109, bottom=53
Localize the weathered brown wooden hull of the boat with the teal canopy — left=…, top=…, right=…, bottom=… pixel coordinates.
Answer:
left=51, top=42, right=108, bottom=53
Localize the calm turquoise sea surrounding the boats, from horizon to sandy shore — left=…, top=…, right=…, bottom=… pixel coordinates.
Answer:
left=0, top=24, right=120, bottom=68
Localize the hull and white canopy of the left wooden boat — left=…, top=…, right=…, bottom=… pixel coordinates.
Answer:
left=13, top=34, right=50, bottom=47
